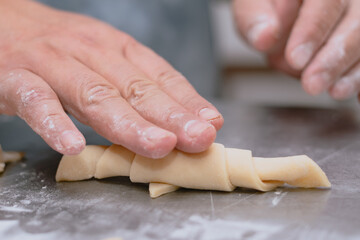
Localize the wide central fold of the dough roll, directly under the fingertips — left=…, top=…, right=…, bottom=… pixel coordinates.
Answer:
left=130, top=144, right=235, bottom=191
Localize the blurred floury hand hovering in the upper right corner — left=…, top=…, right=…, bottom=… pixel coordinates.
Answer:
left=234, top=0, right=360, bottom=99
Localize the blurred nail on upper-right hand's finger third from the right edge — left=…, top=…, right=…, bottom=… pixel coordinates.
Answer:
left=290, top=42, right=314, bottom=70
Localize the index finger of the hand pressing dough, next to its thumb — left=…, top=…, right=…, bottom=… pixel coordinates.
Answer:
left=28, top=55, right=176, bottom=158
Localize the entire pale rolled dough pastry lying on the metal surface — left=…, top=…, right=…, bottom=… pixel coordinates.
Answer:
left=56, top=143, right=331, bottom=197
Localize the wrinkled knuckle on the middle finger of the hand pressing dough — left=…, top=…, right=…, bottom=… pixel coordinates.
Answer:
left=123, top=77, right=157, bottom=106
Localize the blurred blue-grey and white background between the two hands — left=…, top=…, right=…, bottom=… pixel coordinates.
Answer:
left=36, top=0, right=357, bottom=108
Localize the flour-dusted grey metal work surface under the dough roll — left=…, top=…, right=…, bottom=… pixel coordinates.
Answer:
left=0, top=102, right=360, bottom=240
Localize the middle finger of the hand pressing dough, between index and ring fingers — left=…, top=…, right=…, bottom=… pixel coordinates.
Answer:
left=71, top=46, right=216, bottom=152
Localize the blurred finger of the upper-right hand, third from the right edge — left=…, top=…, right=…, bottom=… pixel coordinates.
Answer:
left=286, top=0, right=348, bottom=70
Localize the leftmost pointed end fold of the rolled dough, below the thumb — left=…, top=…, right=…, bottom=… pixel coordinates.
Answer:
left=56, top=145, right=106, bottom=181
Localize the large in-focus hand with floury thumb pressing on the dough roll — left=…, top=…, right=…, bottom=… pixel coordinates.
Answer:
left=0, top=0, right=223, bottom=158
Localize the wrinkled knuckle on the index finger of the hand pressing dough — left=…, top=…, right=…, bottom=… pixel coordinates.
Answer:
left=79, top=82, right=120, bottom=108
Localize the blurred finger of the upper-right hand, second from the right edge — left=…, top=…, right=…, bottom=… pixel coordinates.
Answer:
left=302, top=1, right=360, bottom=94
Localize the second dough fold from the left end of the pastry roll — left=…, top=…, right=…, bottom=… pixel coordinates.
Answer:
left=95, top=144, right=135, bottom=179
